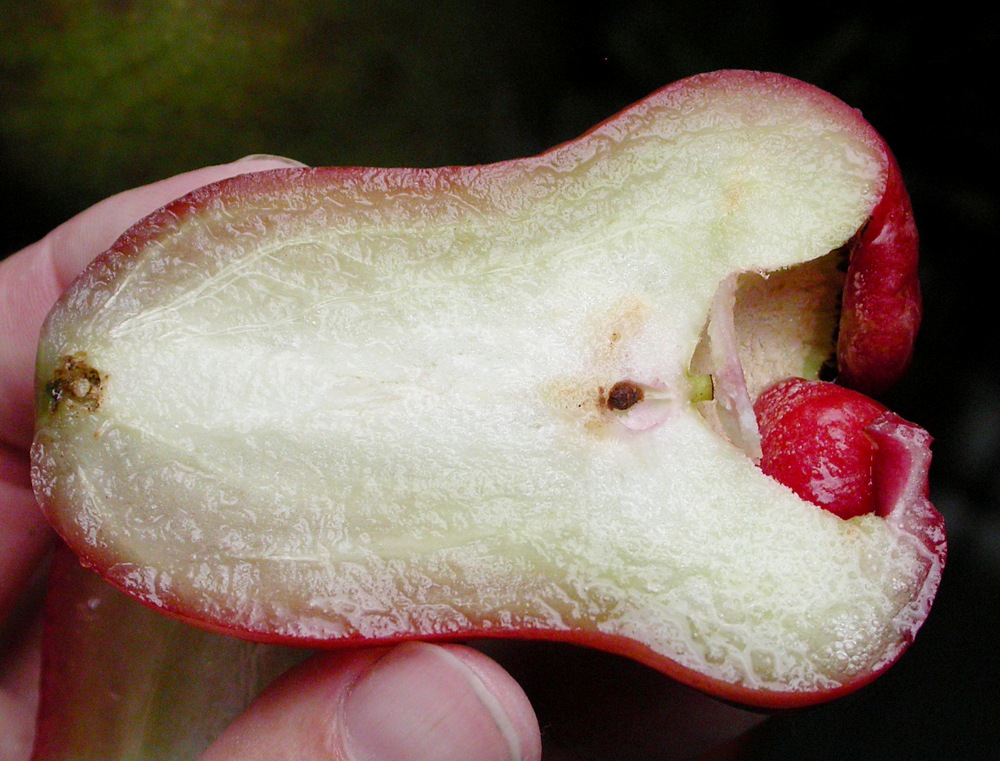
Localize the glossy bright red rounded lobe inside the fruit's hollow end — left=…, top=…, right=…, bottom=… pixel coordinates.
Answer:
left=754, top=378, right=888, bottom=518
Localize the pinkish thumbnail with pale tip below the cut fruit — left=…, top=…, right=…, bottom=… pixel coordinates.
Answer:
left=344, top=642, right=522, bottom=761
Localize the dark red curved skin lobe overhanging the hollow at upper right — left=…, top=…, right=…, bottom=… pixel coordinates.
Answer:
left=837, top=150, right=923, bottom=396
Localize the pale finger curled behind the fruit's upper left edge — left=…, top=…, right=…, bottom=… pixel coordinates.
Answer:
left=0, top=156, right=302, bottom=448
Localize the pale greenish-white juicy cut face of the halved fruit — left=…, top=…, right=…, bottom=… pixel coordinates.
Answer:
left=27, top=75, right=940, bottom=705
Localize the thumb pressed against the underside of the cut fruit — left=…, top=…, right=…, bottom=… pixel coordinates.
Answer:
left=201, top=642, right=541, bottom=761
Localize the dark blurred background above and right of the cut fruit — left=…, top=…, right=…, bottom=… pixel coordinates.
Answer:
left=0, top=0, right=1000, bottom=760
